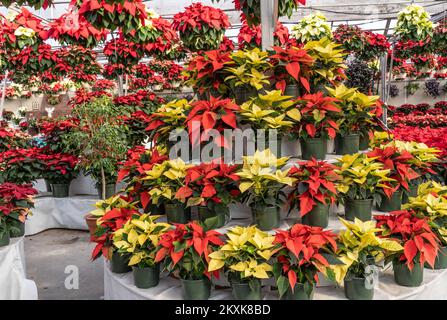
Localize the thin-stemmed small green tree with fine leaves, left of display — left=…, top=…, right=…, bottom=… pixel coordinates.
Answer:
left=68, top=95, right=128, bottom=199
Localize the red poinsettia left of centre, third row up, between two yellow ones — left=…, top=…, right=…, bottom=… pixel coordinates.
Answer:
left=186, top=97, right=240, bottom=148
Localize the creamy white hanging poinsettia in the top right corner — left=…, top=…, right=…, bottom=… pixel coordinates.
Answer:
left=395, top=4, right=433, bottom=41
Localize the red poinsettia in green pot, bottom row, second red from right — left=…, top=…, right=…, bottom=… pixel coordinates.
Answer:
left=273, top=224, right=337, bottom=300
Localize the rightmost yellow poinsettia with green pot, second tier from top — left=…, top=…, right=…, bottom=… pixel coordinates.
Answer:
left=327, top=84, right=379, bottom=155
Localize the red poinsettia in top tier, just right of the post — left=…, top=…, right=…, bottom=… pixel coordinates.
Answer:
left=270, top=47, right=314, bottom=92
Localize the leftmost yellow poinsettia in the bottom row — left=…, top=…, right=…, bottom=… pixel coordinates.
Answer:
left=113, top=214, right=171, bottom=268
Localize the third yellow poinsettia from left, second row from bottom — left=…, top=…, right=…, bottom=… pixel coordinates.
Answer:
left=335, top=153, right=395, bottom=202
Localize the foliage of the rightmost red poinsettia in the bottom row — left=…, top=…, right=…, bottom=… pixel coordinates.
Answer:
left=374, top=210, right=439, bottom=270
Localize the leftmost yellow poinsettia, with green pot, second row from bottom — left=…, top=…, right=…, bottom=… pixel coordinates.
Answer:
left=138, top=158, right=192, bottom=223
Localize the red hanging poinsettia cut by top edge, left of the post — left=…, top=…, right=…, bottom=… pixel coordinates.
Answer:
left=70, top=0, right=147, bottom=33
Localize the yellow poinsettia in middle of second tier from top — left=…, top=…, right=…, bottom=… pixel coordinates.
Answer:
left=239, top=90, right=301, bottom=134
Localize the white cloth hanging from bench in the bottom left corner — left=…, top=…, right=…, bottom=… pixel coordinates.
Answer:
left=0, top=237, right=37, bottom=300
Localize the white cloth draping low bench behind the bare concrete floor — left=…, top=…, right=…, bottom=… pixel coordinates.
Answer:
left=25, top=196, right=98, bottom=235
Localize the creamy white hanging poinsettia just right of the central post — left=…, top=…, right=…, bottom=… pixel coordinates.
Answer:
left=292, top=12, right=332, bottom=43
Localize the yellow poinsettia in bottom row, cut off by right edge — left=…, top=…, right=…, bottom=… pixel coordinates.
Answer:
left=402, top=181, right=447, bottom=270
